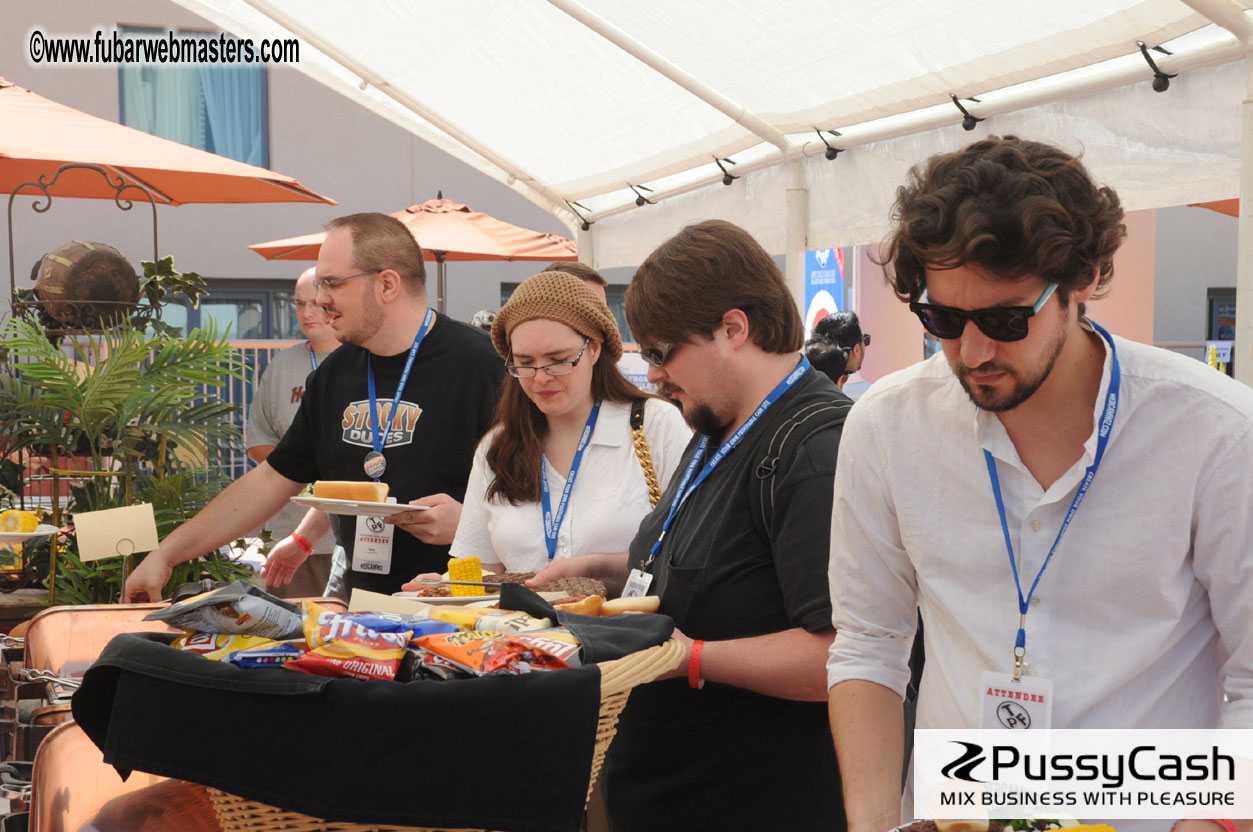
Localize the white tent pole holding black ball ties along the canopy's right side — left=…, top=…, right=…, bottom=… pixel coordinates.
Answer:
left=583, top=34, right=1245, bottom=222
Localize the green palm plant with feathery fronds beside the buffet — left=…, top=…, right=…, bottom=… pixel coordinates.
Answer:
left=0, top=318, right=254, bottom=603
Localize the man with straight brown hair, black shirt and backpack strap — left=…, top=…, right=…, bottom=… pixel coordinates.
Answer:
left=535, top=221, right=851, bottom=832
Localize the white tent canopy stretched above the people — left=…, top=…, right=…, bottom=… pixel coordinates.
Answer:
left=175, top=0, right=1253, bottom=381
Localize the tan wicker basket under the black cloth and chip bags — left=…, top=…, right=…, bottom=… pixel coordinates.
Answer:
left=208, top=639, right=683, bottom=832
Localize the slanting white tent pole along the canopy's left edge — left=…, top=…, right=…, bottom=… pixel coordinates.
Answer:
left=244, top=0, right=578, bottom=228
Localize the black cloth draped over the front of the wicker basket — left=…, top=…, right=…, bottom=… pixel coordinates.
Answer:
left=73, top=633, right=600, bottom=832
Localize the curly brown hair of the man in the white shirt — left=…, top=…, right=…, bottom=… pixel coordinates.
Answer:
left=875, top=135, right=1126, bottom=303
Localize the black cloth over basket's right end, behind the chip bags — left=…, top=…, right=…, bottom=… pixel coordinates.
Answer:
left=500, top=584, right=674, bottom=664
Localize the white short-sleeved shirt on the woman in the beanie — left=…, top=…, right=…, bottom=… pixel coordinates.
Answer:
left=451, top=398, right=692, bottom=571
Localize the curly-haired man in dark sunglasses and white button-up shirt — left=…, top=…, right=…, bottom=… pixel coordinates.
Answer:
left=827, top=137, right=1253, bottom=832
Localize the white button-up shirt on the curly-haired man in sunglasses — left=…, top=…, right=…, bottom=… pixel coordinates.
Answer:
left=827, top=325, right=1253, bottom=728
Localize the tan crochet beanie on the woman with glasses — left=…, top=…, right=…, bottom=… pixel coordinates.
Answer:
left=491, top=272, right=623, bottom=363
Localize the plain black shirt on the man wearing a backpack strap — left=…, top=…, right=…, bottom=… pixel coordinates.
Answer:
left=605, top=370, right=846, bottom=832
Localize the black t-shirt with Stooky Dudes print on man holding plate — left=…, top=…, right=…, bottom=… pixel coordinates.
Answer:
left=267, top=316, right=505, bottom=593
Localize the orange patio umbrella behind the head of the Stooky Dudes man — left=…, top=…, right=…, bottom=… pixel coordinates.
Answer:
left=248, top=195, right=579, bottom=312
